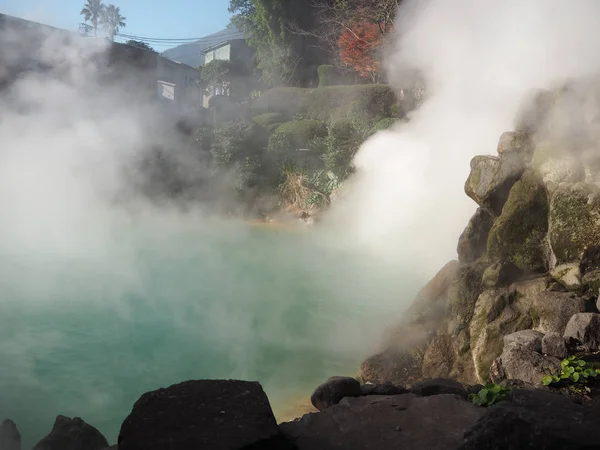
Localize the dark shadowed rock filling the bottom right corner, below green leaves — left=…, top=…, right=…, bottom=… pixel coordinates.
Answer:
left=458, top=389, right=600, bottom=450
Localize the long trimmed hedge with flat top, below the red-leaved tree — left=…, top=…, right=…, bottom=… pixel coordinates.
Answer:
left=252, top=84, right=402, bottom=121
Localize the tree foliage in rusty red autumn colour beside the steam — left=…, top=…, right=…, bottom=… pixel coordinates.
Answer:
left=338, top=22, right=384, bottom=78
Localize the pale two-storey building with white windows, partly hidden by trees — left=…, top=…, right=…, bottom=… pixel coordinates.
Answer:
left=202, top=38, right=254, bottom=108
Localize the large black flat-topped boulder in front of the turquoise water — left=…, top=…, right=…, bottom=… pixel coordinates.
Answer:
left=118, top=380, right=291, bottom=450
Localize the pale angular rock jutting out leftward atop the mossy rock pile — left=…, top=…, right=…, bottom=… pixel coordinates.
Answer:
left=465, top=156, right=523, bottom=217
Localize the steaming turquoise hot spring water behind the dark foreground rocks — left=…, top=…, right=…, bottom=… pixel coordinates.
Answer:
left=0, top=220, right=421, bottom=448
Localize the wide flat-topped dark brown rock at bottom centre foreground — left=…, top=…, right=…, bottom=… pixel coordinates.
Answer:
left=281, top=394, right=484, bottom=450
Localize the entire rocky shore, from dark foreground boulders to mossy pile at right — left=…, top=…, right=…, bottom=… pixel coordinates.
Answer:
left=0, top=82, right=600, bottom=450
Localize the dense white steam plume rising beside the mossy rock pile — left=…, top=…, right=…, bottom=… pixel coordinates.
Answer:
left=338, top=0, right=600, bottom=275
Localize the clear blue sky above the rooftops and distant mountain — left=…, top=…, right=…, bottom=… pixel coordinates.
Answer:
left=0, top=0, right=230, bottom=51
